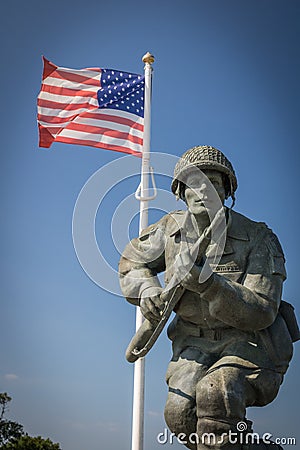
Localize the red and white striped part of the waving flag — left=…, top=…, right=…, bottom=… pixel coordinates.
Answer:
left=38, top=58, right=144, bottom=156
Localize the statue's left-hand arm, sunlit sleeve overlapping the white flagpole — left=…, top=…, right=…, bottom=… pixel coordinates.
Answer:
left=119, top=217, right=167, bottom=305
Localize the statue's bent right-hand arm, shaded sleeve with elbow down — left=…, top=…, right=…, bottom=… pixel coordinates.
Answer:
left=202, top=229, right=286, bottom=330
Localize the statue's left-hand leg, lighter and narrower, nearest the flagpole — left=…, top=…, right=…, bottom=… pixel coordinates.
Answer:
left=165, top=358, right=207, bottom=450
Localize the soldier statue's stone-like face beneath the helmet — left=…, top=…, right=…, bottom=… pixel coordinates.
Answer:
left=184, top=170, right=225, bottom=215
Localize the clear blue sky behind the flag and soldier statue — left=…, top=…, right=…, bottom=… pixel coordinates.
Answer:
left=0, top=0, right=300, bottom=450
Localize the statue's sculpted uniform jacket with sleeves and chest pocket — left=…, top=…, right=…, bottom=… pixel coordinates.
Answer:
left=119, top=210, right=292, bottom=373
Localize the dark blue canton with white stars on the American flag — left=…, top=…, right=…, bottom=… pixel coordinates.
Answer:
left=97, top=69, right=145, bottom=117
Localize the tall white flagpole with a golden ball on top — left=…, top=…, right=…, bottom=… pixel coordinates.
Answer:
left=131, top=52, right=154, bottom=450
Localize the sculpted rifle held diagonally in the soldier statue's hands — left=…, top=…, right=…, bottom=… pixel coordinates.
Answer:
left=125, top=208, right=224, bottom=363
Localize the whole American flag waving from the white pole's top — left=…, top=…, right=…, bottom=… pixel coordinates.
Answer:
left=38, top=58, right=145, bottom=156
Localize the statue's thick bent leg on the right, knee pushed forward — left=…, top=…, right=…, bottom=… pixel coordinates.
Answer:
left=196, top=366, right=283, bottom=450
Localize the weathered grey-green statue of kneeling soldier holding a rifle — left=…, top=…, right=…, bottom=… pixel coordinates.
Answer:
left=119, top=146, right=300, bottom=450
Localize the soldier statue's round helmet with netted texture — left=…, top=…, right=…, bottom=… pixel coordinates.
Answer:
left=171, top=145, right=238, bottom=203
